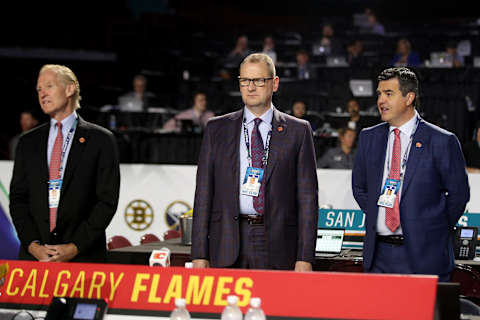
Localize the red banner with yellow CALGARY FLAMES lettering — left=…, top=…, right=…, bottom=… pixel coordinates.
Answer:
left=0, top=261, right=437, bottom=320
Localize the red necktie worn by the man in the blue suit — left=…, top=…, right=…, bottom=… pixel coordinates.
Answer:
left=385, top=129, right=402, bottom=232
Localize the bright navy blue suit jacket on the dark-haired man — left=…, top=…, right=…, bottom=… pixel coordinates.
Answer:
left=352, top=119, right=470, bottom=274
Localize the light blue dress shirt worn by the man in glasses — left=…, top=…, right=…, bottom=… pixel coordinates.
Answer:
left=239, top=105, right=273, bottom=215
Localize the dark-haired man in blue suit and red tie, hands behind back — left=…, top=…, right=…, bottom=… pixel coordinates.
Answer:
left=352, top=67, right=470, bottom=281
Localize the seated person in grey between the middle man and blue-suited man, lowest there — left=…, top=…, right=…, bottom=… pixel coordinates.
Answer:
left=317, top=128, right=357, bottom=169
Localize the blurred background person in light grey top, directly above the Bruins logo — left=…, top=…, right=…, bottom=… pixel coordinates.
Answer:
left=118, top=74, right=156, bottom=111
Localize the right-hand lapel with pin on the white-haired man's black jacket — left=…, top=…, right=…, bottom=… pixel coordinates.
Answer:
left=62, top=116, right=89, bottom=193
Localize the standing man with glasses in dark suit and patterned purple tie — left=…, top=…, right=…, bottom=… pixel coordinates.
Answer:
left=191, top=54, right=318, bottom=271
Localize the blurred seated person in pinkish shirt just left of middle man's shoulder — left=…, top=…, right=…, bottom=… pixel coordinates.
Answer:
left=163, top=92, right=214, bottom=132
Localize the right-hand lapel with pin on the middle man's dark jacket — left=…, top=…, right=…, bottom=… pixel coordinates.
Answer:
left=265, top=108, right=287, bottom=184
